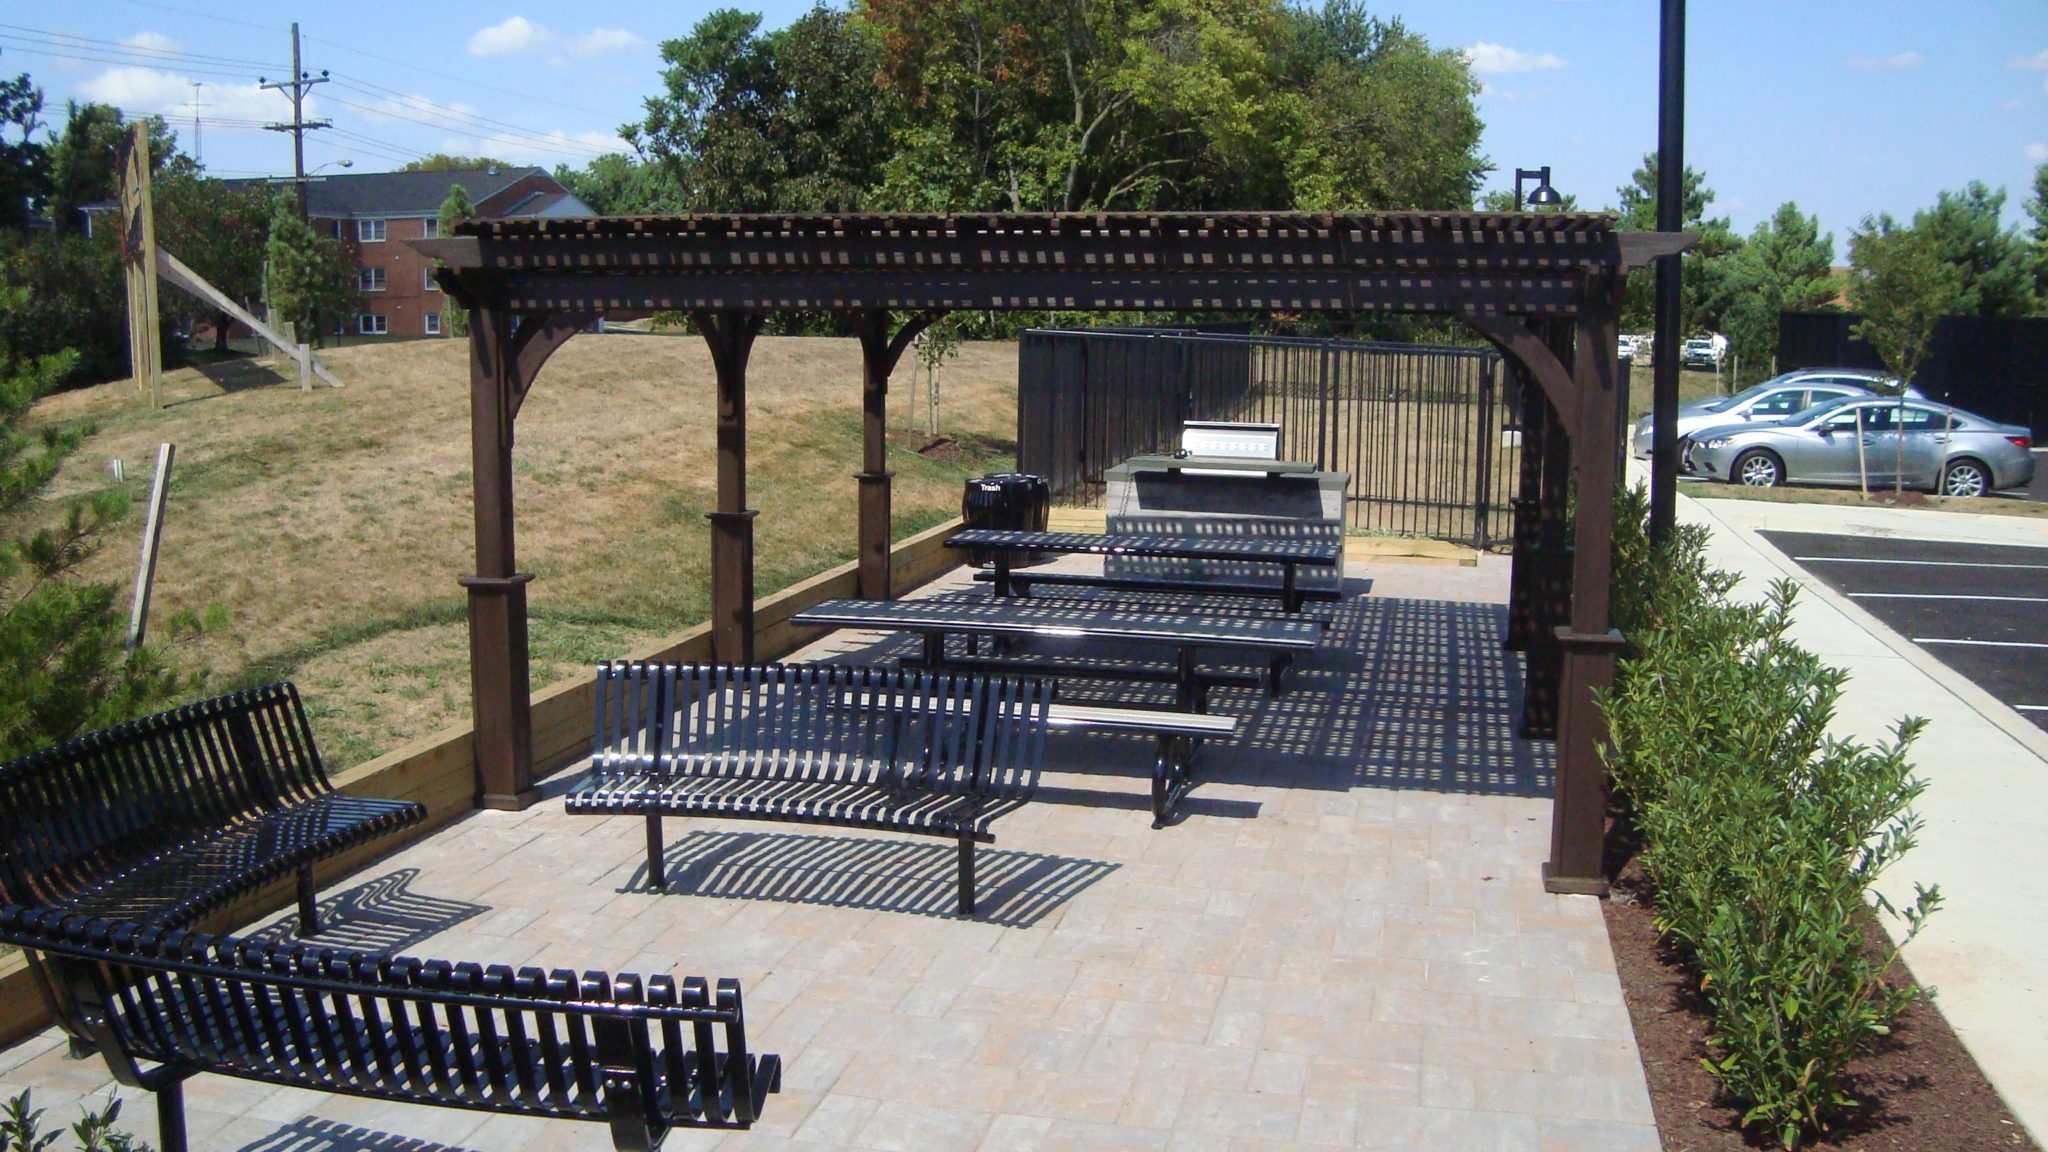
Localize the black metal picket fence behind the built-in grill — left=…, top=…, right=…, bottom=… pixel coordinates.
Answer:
left=1018, top=330, right=1520, bottom=547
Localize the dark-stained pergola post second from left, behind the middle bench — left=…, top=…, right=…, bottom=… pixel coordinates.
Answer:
left=690, top=310, right=764, bottom=664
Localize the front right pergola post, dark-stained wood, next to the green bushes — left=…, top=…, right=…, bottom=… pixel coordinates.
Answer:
left=1544, top=269, right=1622, bottom=896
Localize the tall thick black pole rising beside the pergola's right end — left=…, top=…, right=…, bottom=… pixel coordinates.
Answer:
left=1651, top=0, right=1686, bottom=543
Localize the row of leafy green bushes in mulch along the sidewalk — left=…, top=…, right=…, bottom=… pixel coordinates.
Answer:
left=1602, top=481, right=1939, bottom=1148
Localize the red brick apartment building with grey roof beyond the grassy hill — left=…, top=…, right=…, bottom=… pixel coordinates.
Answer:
left=242, top=168, right=598, bottom=336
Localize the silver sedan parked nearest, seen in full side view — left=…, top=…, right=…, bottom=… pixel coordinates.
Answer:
left=1686, top=398, right=2034, bottom=496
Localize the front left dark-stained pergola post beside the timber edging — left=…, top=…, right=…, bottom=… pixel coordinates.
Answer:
left=461, top=307, right=537, bottom=810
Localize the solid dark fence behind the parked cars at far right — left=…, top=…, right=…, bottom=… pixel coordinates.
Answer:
left=1778, top=312, right=2048, bottom=437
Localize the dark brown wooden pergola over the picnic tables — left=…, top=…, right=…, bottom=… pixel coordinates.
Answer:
left=414, top=213, right=1690, bottom=892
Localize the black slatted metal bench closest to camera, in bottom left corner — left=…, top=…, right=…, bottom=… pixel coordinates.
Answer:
left=0, top=906, right=782, bottom=1152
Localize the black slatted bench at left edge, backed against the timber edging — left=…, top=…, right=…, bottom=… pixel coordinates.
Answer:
left=0, top=683, right=426, bottom=935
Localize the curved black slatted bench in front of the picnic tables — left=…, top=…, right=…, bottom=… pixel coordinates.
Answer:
left=563, top=662, right=1053, bottom=914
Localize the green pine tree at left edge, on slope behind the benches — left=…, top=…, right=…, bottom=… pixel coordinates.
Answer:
left=0, top=289, right=180, bottom=760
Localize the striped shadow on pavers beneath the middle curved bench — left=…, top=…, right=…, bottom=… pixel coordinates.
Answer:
left=623, top=830, right=1116, bottom=929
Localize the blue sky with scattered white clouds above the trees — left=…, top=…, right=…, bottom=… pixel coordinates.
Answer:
left=0, top=0, right=2048, bottom=243
